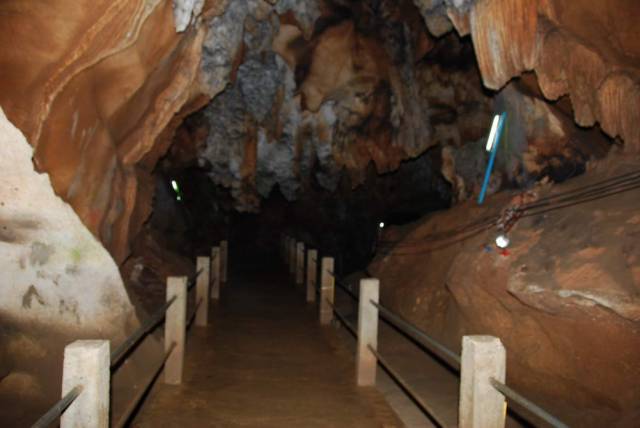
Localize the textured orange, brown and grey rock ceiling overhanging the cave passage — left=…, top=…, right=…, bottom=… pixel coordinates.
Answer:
left=0, top=0, right=640, bottom=261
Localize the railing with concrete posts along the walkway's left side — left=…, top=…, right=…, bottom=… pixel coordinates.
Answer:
left=32, top=241, right=228, bottom=428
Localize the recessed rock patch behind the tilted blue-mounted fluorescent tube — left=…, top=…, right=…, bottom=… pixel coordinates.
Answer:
left=442, top=75, right=610, bottom=201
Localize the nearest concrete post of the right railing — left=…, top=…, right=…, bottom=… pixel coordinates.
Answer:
left=458, top=336, right=507, bottom=428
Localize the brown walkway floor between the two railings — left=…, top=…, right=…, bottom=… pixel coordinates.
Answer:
left=132, top=260, right=402, bottom=428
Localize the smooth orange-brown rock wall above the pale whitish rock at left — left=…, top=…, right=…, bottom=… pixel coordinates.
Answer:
left=0, top=0, right=205, bottom=261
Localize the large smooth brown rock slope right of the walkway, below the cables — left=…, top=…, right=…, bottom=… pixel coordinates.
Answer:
left=370, top=158, right=640, bottom=427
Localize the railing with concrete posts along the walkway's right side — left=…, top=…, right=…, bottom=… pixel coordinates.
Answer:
left=282, top=236, right=568, bottom=428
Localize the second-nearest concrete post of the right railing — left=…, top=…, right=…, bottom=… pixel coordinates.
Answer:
left=356, top=278, right=380, bottom=386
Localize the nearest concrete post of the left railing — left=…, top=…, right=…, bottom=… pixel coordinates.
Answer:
left=60, top=340, right=111, bottom=428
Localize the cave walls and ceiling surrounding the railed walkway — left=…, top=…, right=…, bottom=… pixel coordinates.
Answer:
left=0, top=0, right=640, bottom=427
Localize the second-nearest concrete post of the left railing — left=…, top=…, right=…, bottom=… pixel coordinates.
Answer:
left=164, top=277, right=187, bottom=385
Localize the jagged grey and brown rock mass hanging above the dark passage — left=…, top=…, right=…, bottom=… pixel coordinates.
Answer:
left=185, top=2, right=490, bottom=211
